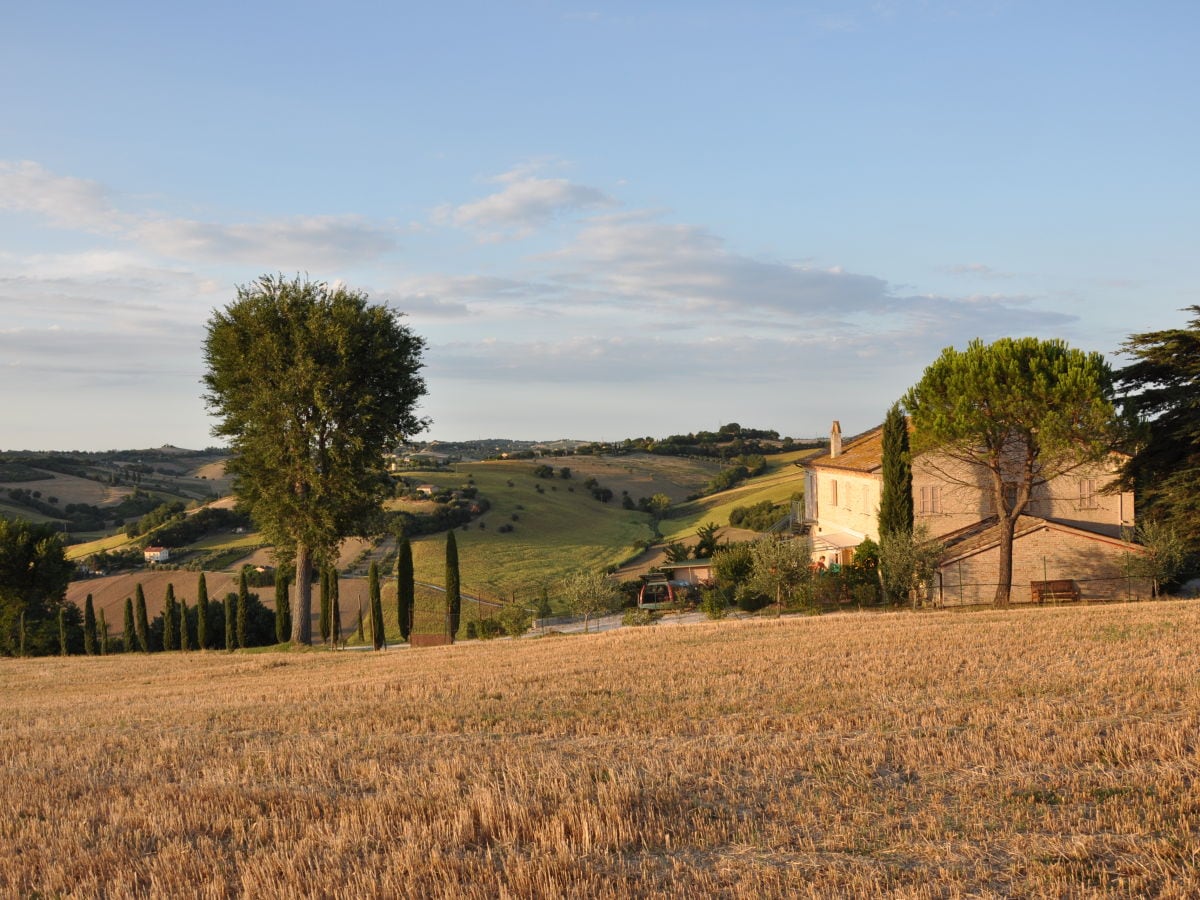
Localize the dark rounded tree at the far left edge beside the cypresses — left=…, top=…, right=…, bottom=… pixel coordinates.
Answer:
left=0, top=518, right=72, bottom=655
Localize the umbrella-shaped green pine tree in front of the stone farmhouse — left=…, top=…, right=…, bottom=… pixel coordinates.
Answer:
left=904, top=337, right=1121, bottom=606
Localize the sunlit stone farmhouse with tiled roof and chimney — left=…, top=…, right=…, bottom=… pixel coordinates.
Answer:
left=804, top=421, right=1150, bottom=605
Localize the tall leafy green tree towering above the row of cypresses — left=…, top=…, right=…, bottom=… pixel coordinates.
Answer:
left=204, top=276, right=425, bottom=643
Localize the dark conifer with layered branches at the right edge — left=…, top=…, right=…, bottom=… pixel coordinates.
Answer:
left=1117, top=306, right=1200, bottom=552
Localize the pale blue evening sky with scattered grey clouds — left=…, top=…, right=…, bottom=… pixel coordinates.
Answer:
left=0, top=0, right=1200, bottom=450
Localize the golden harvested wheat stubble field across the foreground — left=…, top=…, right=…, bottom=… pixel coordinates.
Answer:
left=0, top=602, right=1200, bottom=898
